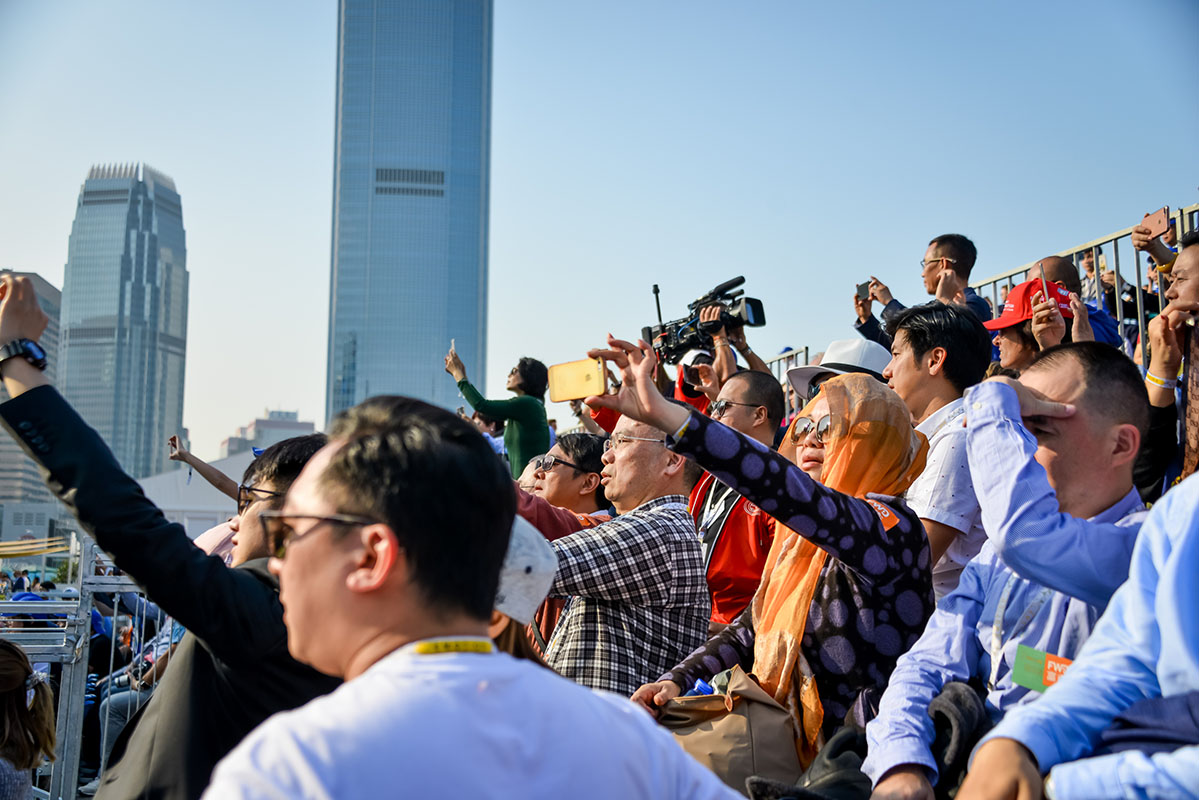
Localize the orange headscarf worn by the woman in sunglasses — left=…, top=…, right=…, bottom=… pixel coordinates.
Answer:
left=753, top=373, right=928, bottom=768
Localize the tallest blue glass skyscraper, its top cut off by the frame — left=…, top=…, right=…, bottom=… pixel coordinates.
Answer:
left=325, top=0, right=492, bottom=419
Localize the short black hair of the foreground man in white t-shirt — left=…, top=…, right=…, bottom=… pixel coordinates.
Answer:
left=321, top=396, right=517, bottom=620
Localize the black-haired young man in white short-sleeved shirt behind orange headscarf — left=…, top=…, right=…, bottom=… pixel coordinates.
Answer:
left=882, top=302, right=992, bottom=600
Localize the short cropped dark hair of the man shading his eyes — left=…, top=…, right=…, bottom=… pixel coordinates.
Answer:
left=1024, top=342, right=1149, bottom=441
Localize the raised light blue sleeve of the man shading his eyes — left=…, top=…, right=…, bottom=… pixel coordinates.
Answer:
left=965, top=381, right=1145, bottom=608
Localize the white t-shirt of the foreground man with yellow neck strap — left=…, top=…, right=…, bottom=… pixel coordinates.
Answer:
left=204, top=639, right=741, bottom=800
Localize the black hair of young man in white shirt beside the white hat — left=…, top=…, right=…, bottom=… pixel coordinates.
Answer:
left=887, top=302, right=990, bottom=392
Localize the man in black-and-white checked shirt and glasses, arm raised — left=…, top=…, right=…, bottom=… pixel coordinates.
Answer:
left=520, top=410, right=710, bottom=697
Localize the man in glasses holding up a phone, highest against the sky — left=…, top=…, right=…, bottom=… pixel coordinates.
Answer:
left=854, top=234, right=992, bottom=348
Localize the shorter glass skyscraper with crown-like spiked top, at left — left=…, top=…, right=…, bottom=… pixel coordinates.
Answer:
left=59, top=164, right=187, bottom=477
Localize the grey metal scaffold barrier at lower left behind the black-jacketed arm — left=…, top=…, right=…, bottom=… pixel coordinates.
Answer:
left=0, top=535, right=147, bottom=800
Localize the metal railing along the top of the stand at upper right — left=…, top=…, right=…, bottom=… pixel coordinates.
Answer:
left=970, top=204, right=1199, bottom=365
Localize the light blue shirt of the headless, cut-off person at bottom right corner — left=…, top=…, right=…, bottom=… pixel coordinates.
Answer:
left=984, top=476, right=1199, bottom=800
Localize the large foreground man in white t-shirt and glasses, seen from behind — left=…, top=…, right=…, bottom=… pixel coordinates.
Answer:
left=205, top=397, right=739, bottom=800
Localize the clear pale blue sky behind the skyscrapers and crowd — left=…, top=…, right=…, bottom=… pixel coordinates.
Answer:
left=0, top=0, right=1199, bottom=457
